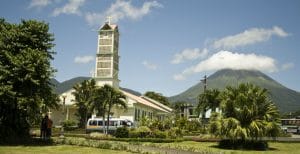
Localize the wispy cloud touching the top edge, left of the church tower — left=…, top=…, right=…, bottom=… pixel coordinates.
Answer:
left=52, top=0, right=86, bottom=16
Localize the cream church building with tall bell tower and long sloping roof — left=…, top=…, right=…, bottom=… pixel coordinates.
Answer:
left=51, top=21, right=172, bottom=125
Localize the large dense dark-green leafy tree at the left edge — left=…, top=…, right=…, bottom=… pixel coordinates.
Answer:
left=0, top=19, right=58, bottom=138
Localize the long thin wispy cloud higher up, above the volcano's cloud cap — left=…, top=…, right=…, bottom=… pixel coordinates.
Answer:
left=213, top=26, right=289, bottom=49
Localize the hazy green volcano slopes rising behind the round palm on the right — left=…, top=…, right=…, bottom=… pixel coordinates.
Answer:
left=169, top=69, right=300, bottom=112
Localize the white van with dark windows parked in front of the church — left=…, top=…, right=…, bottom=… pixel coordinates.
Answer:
left=86, top=118, right=133, bottom=133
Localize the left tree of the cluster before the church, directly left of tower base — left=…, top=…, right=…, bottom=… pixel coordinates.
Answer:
left=72, top=79, right=96, bottom=128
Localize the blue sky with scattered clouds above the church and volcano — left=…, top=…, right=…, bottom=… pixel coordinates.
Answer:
left=0, top=0, right=300, bottom=96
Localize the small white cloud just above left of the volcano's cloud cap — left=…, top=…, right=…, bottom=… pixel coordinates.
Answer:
left=171, top=48, right=208, bottom=64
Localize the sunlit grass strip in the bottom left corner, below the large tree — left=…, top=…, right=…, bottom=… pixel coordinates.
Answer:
left=0, top=145, right=130, bottom=154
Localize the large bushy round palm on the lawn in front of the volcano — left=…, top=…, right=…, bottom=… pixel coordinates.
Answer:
left=210, top=84, right=280, bottom=140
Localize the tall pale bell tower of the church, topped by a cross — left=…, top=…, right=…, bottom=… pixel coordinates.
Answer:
left=94, top=20, right=120, bottom=89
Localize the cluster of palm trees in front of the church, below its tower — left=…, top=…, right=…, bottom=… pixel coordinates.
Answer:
left=72, top=82, right=127, bottom=133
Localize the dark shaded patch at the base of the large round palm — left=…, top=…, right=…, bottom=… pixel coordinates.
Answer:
left=219, top=139, right=268, bottom=150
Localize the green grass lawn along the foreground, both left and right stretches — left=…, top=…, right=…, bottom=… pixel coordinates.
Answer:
left=0, top=141, right=300, bottom=154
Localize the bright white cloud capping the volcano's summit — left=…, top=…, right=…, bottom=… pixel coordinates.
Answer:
left=173, top=51, right=278, bottom=80
